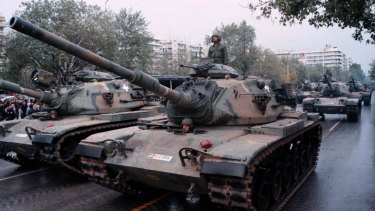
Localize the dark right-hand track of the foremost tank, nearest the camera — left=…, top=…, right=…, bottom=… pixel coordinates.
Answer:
left=207, top=122, right=322, bottom=210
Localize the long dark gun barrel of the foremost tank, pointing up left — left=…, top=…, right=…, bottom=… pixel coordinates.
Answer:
left=9, top=17, right=191, bottom=107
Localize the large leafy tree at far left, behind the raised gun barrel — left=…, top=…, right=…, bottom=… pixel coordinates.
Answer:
left=3, top=0, right=112, bottom=85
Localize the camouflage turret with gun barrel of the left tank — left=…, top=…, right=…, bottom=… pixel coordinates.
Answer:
left=0, top=80, right=147, bottom=115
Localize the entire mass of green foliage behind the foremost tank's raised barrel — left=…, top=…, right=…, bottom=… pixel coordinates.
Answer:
left=2, top=0, right=151, bottom=82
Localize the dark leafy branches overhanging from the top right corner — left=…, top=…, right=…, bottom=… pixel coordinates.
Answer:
left=249, top=0, right=375, bottom=44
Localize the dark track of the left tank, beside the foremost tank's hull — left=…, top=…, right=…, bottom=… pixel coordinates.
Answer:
left=40, top=121, right=137, bottom=175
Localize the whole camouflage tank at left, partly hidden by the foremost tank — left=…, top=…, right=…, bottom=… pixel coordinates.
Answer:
left=0, top=76, right=164, bottom=167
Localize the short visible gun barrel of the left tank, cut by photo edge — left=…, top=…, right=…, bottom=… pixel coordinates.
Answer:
left=0, top=79, right=53, bottom=104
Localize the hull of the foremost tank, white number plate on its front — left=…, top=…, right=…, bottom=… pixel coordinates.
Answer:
left=79, top=114, right=321, bottom=209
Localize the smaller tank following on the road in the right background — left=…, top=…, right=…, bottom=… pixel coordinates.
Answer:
left=302, top=73, right=362, bottom=122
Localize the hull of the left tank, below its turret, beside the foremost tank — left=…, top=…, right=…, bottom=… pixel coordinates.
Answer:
left=0, top=106, right=164, bottom=168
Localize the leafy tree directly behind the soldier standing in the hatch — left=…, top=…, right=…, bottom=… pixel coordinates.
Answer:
left=205, top=21, right=257, bottom=73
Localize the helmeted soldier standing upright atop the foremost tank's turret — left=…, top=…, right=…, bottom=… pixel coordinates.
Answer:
left=208, top=34, right=228, bottom=64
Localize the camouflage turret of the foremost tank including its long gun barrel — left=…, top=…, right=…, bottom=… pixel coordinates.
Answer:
left=10, top=17, right=287, bottom=125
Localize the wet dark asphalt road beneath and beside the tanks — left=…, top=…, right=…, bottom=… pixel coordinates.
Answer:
left=0, top=102, right=375, bottom=211
